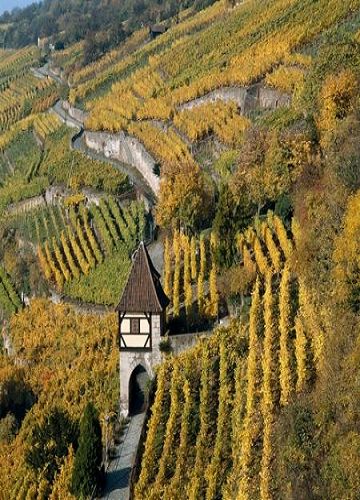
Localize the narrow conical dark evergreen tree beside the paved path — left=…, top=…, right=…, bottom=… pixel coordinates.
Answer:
left=71, top=403, right=102, bottom=498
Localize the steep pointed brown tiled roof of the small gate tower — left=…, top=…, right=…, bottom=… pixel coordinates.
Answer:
left=116, top=241, right=170, bottom=313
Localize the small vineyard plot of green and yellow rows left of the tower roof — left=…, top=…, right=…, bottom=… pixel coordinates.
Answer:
left=35, top=197, right=145, bottom=303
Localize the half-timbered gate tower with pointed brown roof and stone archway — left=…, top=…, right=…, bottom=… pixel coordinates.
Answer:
left=116, top=242, right=169, bottom=416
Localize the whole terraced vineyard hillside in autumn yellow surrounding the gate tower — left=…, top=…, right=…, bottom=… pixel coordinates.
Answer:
left=0, top=0, right=360, bottom=500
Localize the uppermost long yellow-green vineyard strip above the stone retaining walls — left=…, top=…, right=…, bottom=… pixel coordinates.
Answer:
left=75, top=0, right=356, bottom=133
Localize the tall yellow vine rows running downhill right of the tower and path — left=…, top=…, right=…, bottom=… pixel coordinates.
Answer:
left=135, top=213, right=323, bottom=499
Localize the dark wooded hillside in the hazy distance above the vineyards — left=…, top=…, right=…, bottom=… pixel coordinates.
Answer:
left=0, top=0, right=214, bottom=51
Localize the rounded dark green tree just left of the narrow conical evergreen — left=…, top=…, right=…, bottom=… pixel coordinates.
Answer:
left=25, top=407, right=78, bottom=482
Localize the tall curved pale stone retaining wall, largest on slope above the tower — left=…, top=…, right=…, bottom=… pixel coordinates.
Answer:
left=84, top=131, right=160, bottom=195
